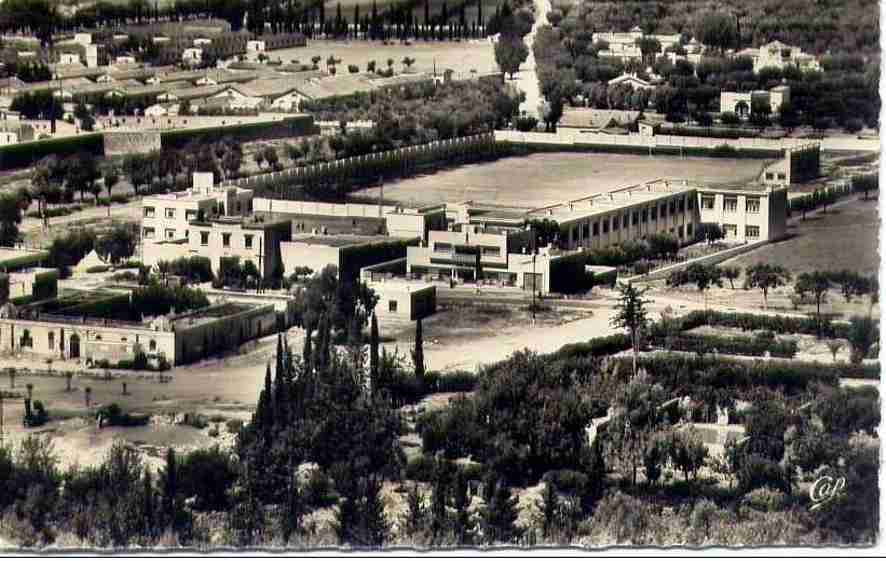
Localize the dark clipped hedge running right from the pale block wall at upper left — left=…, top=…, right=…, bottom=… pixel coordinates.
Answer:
left=160, top=116, right=316, bottom=149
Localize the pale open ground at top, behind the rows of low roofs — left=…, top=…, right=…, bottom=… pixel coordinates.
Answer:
left=268, top=38, right=498, bottom=73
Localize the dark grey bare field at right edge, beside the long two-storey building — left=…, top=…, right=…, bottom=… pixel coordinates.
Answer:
left=728, top=196, right=880, bottom=275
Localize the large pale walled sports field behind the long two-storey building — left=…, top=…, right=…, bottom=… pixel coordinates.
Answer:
left=355, top=153, right=762, bottom=208
